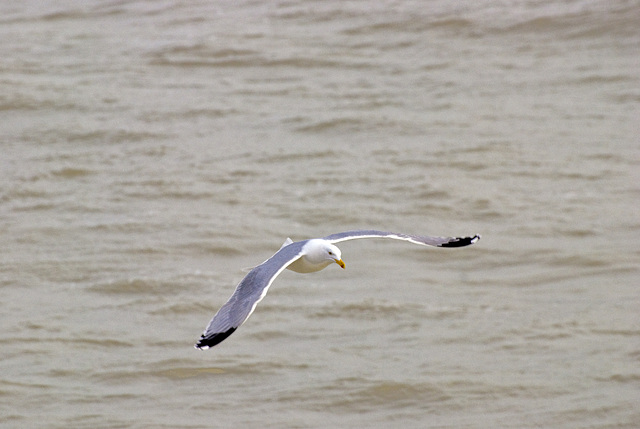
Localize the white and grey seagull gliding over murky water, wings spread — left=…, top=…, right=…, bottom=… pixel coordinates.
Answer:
left=195, top=230, right=480, bottom=350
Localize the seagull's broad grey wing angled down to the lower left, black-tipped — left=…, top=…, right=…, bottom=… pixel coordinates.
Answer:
left=195, top=241, right=306, bottom=349
